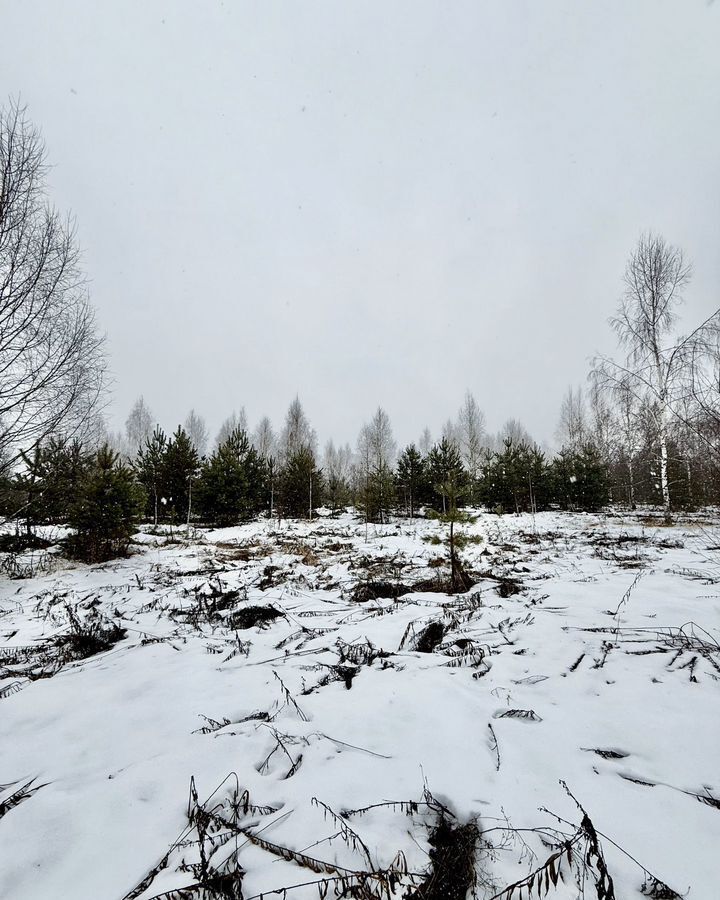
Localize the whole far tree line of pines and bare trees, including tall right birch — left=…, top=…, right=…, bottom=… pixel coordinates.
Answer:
left=1, top=230, right=720, bottom=559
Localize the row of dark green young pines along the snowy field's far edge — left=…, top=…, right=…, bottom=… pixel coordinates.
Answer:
left=1, top=378, right=718, bottom=559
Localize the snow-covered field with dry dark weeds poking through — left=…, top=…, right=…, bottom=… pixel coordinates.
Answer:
left=0, top=513, right=720, bottom=900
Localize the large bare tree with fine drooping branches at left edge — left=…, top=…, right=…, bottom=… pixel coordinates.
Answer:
left=0, top=102, right=105, bottom=468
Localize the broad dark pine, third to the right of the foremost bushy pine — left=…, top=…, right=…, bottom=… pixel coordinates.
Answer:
left=197, top=428, right=266, bottom=525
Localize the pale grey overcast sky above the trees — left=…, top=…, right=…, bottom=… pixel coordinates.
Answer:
left=0, top=0, right=720, bottom=443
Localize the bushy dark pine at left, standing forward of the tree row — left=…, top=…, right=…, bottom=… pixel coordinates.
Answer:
left=68, top=445, right=144, bottom=562
